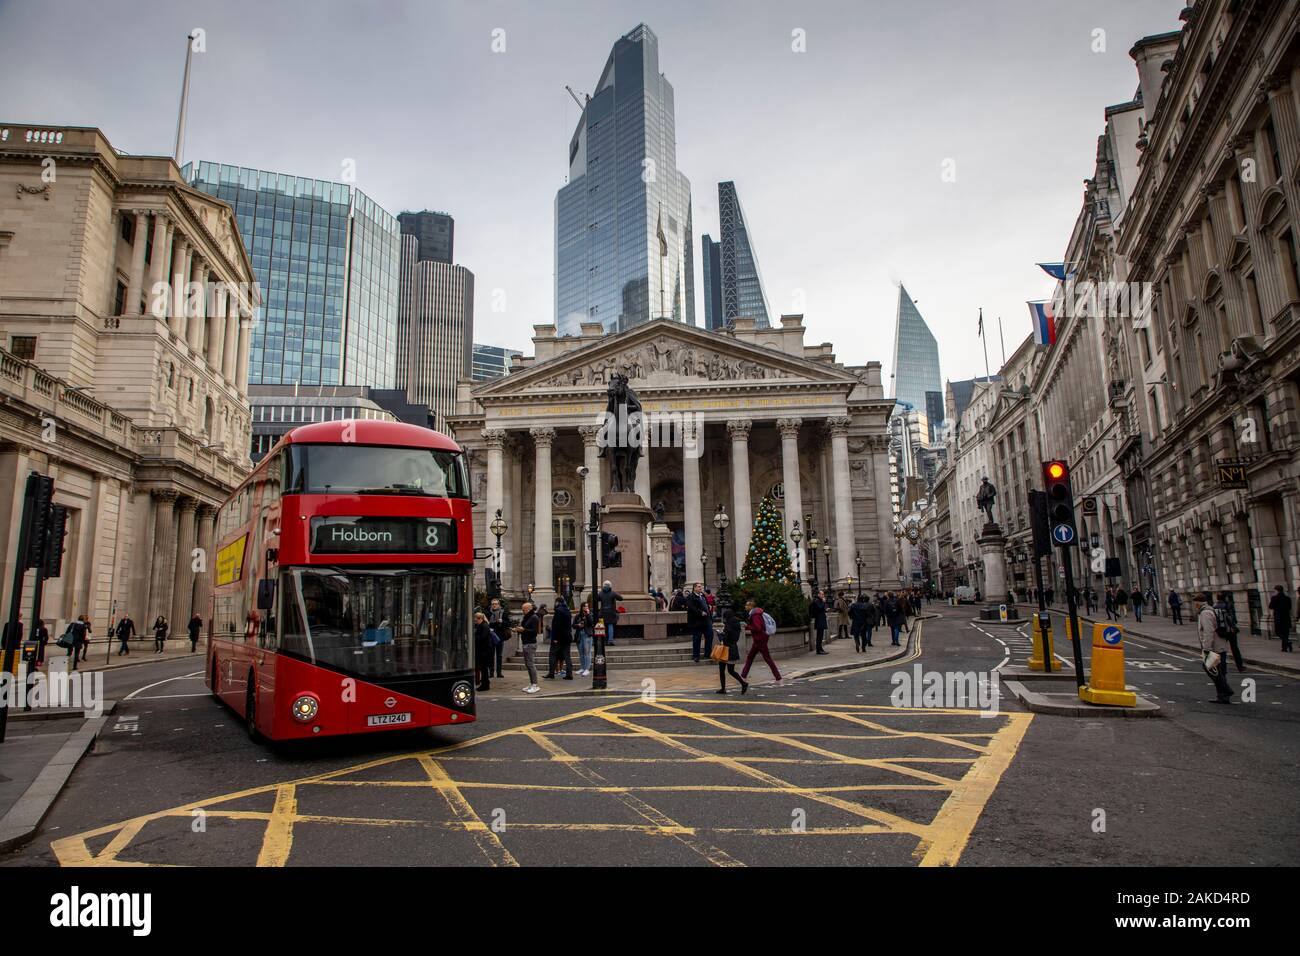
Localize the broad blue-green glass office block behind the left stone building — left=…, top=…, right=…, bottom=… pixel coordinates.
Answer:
left=185, top=163, right=400, bottom=389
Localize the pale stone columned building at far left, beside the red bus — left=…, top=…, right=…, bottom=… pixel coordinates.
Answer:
left=0, top=124, right=259, bottom=636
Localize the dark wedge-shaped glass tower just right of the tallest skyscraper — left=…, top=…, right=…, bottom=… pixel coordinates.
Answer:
left=703, top=182, right=772, bottom=329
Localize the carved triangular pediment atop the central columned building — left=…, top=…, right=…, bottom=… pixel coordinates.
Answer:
left=473, top=319, right=859, bottom=399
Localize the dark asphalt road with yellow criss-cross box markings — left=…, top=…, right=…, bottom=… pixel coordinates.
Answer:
left=3, top=607, right=1300, bottom=865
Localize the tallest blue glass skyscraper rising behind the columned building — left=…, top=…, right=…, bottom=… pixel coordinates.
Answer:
left=555, top=23, right=696, bottom=334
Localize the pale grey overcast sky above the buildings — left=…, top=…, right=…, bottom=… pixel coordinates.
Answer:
left=0, top=0, right=1183, bottom=382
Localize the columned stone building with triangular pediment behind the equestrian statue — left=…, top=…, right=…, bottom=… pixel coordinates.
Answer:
left=449, top=316, right=897, bottom=600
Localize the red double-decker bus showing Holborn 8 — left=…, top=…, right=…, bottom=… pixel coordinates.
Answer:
left=207, top=420, right=475, bottom=740
